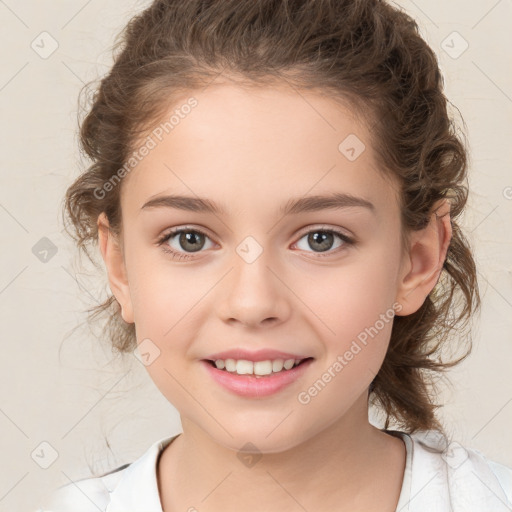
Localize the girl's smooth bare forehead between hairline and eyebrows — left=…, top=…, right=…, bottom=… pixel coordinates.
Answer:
left=122, top=84, right=395, bottom=219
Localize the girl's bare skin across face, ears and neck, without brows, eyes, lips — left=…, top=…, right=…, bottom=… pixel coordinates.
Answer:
left=98, top=82, right=451, bottom=512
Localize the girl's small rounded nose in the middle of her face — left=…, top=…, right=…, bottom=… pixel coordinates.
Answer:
left=218, top=247, right=293, bottom=327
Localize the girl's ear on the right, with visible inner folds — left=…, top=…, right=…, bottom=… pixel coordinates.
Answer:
left=396, top=199, right=452, bottom=316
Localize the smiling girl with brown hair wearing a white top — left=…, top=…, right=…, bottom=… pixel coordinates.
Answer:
left=38, top=0, right=512, bottom=512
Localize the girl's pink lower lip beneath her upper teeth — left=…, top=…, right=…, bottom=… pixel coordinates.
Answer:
left=201, top=359, right=313, bottom=398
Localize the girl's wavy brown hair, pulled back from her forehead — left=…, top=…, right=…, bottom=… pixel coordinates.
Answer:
left=64, top=0, right=480, bottom=433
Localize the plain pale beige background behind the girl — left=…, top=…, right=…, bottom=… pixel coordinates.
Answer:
left=0, top=0, right=512, bottom=511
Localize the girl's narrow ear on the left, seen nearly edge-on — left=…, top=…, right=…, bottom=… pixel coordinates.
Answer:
left=98, top=212, right=134, bottom=324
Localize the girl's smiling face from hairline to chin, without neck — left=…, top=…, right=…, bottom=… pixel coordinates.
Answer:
left=100, top=84, right=432, bottom=452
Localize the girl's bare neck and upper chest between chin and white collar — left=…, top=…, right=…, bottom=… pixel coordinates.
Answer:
left=158, top=397, right=405, bottom=512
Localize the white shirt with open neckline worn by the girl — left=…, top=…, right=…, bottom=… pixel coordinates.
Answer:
left=37, top=430, right=512, bottom=512
